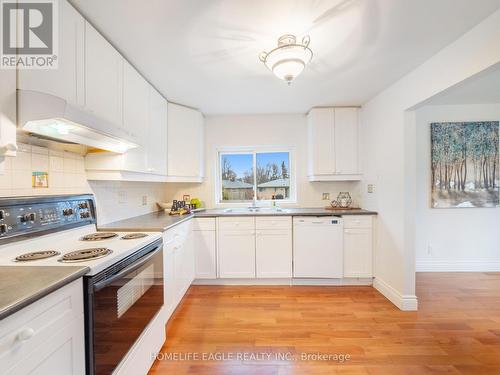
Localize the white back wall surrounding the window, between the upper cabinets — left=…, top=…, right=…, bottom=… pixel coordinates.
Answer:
left=167, top=115, right=360, bottom=208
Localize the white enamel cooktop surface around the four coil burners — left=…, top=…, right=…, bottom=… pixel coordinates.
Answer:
left=0, top=225, right=161, bottom=275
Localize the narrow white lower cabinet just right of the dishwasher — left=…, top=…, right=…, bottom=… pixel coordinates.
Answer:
left=344, top=216, right=373, bottom=278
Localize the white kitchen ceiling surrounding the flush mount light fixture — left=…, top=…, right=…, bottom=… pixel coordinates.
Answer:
left=72, top=0, right=500, bottom=114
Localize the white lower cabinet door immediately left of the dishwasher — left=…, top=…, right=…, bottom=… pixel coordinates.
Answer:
left=255, top=217, right=292, bottom=278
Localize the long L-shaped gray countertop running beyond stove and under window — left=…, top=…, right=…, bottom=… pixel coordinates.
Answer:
left=99, top=208, right=377, bottom=232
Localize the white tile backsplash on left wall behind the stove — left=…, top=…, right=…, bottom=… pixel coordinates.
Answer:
left=0, top=143, right=167, bottom=224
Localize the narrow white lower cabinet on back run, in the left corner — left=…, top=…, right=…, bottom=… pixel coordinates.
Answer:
left=193, top=218, right=217, bottom=279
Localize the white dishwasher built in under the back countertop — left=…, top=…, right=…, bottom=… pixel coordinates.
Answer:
left=293, top=216, right=344, bottom=279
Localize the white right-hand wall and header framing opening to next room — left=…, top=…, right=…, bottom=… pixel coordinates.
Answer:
left=361, top=11, right=500, bottom=310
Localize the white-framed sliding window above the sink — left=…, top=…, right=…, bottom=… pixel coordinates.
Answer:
left=217, top=151, right=293, bottom=203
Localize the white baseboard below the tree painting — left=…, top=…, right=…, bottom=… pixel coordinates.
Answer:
left=416, top=259, right=500, bottom=272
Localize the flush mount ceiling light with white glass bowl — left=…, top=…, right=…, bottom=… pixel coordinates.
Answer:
left=259, top=34, right=312, bottom=84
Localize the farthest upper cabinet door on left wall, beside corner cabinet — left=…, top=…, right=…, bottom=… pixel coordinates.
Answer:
left=146, top=86, right=167, bottom=176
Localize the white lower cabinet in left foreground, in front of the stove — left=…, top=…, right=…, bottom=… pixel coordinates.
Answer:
left=0, top=278, right=85, bottom=375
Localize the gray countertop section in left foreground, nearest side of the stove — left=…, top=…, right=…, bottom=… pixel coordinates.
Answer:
left=0, top=266, right=89, bottom=320
